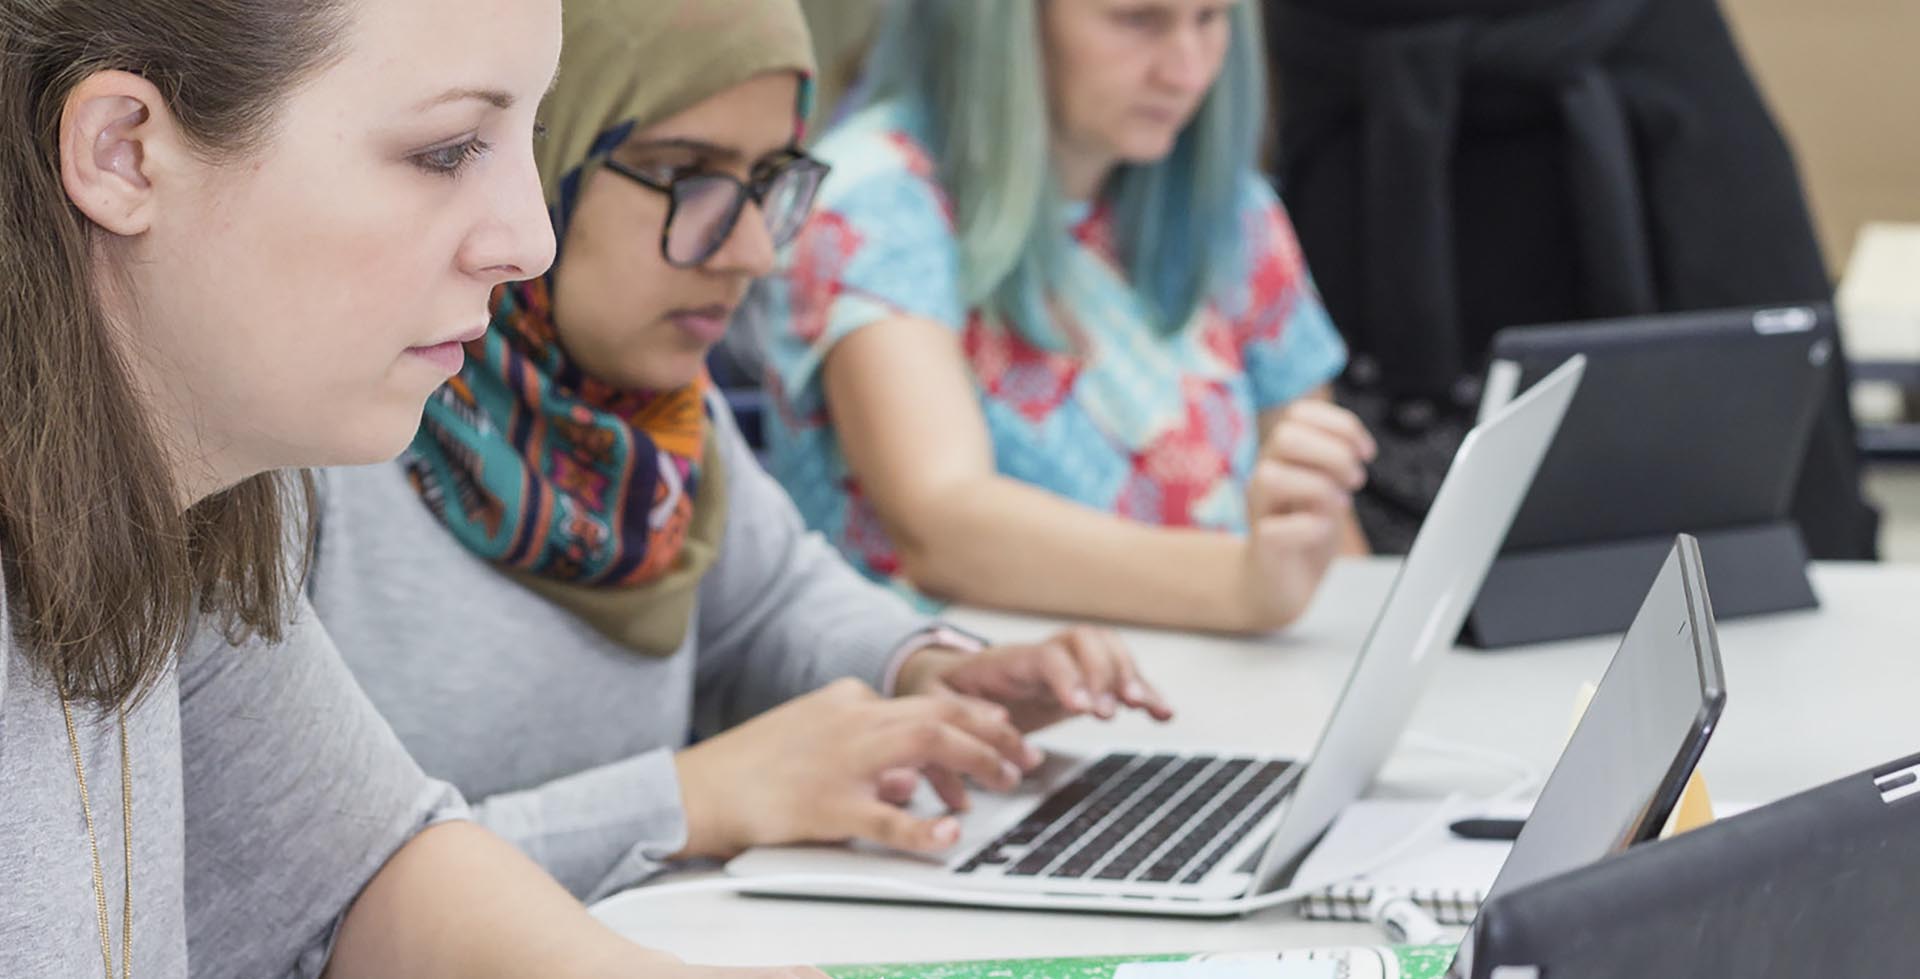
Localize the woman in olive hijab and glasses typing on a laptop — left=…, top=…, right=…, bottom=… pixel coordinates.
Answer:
left=311, top=0, right=1169, bottom=898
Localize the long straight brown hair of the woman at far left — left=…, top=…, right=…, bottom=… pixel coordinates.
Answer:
left=0, top=0, right=348, bottom=706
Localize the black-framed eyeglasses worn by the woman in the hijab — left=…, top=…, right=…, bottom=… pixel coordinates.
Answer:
left=607, top=150, right=829, bottom=269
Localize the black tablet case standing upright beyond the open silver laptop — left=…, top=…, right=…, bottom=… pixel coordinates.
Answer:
left=1465, top=305, right=1836, bottom=649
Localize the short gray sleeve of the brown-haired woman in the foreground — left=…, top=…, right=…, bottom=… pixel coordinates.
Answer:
left=180, top=591, right=465, bottom=977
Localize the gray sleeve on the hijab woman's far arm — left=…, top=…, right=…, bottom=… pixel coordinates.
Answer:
left=695, top=405, right=931, bottom=735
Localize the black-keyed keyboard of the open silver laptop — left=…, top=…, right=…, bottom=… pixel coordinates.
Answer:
left=954, top=752, right=1294, bottom=883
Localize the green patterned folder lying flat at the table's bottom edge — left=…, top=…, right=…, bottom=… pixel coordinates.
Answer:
left=826, top=944, right=1457, bottom=979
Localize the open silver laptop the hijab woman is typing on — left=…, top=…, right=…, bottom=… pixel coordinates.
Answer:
left=728, top=357, right=1586, bottom=916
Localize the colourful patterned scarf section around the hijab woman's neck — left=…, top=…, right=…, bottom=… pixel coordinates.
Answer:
left=407, top=280, right=726, bottom=655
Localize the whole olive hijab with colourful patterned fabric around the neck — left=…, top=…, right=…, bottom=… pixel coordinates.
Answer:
left=407, top=0, right=814, bottom=657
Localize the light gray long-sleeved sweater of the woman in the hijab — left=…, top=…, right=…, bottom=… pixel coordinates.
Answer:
left=311, top=401, right=927, bottom=900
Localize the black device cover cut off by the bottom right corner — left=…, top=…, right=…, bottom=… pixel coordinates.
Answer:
left=1469, top=754, right=1920, bottom=979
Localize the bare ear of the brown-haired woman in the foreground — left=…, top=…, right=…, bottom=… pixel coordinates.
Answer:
left=60, top=71, right=177, bottom=236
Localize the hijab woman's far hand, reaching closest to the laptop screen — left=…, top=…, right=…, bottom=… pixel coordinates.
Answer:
left=899, top=626, right=1173, bottom=733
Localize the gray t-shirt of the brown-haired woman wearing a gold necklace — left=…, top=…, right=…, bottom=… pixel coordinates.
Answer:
left=0, top=552, right=463, bottom=979
